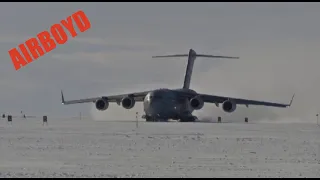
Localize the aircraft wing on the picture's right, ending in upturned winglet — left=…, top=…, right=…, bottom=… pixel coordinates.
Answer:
left=199, top=94, right=294, bottom=108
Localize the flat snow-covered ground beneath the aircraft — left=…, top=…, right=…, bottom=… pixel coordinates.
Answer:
left=0, top=117, right=320, bottom=178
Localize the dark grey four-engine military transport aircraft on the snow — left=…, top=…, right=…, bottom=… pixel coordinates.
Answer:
left=61, top=49, right=294, bottom=122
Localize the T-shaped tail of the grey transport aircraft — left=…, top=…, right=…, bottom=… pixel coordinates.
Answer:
left=152, top=49, right=239, bottom=89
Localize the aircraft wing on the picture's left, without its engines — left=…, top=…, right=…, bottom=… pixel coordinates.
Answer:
left=61, top=91, right=150, bottom=105
